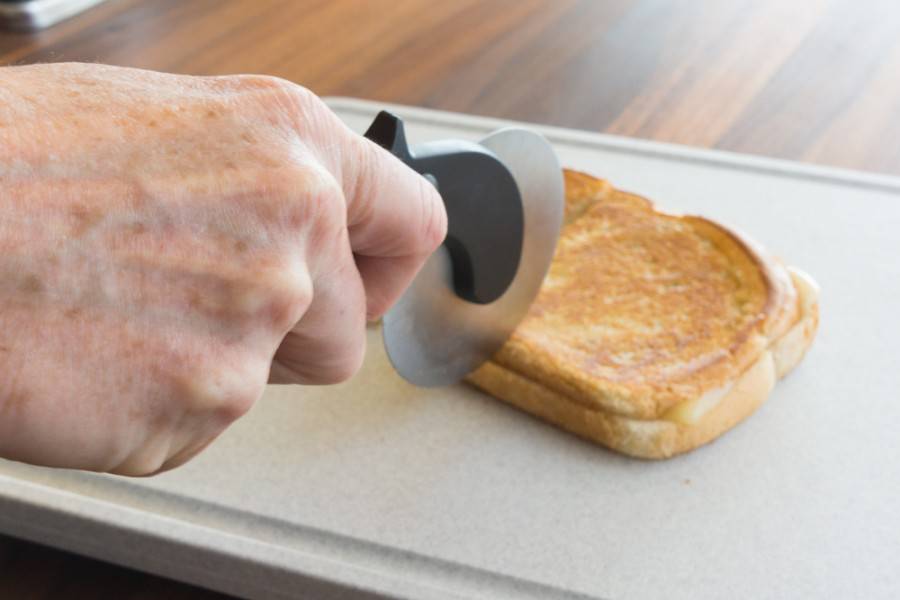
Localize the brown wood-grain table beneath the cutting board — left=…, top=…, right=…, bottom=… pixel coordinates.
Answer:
left=0, top=0, right=900, bottom=600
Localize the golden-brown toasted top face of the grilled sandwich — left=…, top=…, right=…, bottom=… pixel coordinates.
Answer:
left=482, top=172, right=794, bottom=419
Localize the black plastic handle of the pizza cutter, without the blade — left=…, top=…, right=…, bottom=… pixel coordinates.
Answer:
left=365, top=111, right=525, bottom=304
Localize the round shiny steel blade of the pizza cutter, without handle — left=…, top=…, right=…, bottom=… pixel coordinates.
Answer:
left=384, top=128, right=564, bottom=387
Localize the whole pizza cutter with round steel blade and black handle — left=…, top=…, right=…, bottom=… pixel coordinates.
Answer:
left=365, top=112, right=565, bottom=387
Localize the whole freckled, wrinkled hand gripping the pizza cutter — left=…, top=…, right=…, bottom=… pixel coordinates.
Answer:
left=0, top=64, right=446, bottom=475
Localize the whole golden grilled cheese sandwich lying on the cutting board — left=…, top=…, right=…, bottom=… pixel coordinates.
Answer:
left=469, top=171, right=818, bottom=458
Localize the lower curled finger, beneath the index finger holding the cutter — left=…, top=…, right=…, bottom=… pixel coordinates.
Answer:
left=269, top=234, right=366, bottom=384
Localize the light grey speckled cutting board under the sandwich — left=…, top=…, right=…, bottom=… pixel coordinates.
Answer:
left=0, top=99, right=900, bottom=599
